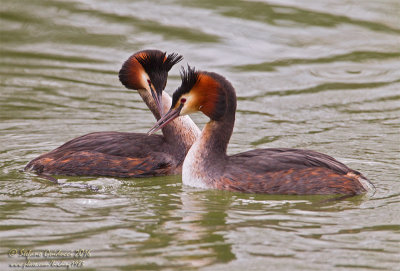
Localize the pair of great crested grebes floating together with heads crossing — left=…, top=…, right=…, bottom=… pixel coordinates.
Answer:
left=25, top=50, right=374, bottom=195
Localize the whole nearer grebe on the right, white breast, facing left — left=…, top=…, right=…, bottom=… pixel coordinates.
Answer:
left=149, top=67, right=374, bottom=195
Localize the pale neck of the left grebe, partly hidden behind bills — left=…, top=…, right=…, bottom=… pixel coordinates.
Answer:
left=139, top=90, right=200, bottom=156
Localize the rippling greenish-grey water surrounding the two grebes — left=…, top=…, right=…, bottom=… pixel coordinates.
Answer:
left=0, top=0, right=400, bottom=270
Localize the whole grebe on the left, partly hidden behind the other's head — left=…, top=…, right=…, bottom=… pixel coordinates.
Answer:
left=25, top=50, right=200, bottom=177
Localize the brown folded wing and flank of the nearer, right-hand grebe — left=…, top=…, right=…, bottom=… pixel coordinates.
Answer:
left=222, top=149, right=364, bottom=195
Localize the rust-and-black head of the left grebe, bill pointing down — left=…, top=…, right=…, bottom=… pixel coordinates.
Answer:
left=119, top=50, right=183, bottom=115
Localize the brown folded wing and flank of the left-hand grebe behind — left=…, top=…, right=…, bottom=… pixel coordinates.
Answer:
left=25, top=132, right=176, bottom=177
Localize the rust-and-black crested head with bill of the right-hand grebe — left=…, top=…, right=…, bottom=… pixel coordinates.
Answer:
left=148, top=66, right=231, bottom=134
